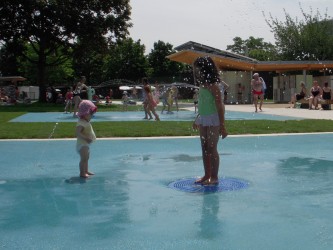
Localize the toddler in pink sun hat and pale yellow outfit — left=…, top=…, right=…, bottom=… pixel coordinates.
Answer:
left=76, top=100, right=97, bottom=178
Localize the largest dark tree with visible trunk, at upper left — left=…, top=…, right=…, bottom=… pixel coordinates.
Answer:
left=0, top=0, right=131, bottom=101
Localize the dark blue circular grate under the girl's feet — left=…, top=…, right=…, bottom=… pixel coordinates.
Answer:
left=168, top=178, right=249, bottom=193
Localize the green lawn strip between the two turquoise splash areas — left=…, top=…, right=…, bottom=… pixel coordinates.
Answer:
left=0, top=103, right=333, bottom=139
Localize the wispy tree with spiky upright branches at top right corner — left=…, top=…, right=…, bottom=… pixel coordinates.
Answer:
left=266, top=4, right=333, bottom=60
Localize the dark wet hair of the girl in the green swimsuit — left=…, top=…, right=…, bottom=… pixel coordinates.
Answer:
left=193, top=56, right=220, bottom=85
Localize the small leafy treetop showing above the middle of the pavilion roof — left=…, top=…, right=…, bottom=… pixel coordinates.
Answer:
left=227, top=36, right=278, bottom=61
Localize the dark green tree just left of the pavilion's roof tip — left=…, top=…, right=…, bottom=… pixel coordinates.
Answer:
left=148, top=41, right=184, bottom=79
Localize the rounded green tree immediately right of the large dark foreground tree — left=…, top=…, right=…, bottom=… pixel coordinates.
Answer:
left=105, top=38, right=148, bottom=81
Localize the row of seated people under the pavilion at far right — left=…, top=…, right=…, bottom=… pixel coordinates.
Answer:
left=290, top=80, right=333, bottom=110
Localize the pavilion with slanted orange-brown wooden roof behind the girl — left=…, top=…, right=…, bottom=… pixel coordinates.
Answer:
left=167, top=41, right=333, bottom=102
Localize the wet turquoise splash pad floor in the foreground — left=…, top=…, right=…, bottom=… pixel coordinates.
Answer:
left=0, top=134, right=333, bottom=250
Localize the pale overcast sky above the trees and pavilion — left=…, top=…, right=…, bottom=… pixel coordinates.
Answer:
left=129, top=0, right=333, bottom=54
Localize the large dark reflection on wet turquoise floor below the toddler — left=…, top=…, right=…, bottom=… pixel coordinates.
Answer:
left=0, top=173, right=131, bottom=242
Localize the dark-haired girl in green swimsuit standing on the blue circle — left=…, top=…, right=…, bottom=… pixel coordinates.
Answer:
left=193, top=57, right=228, bottom=185
